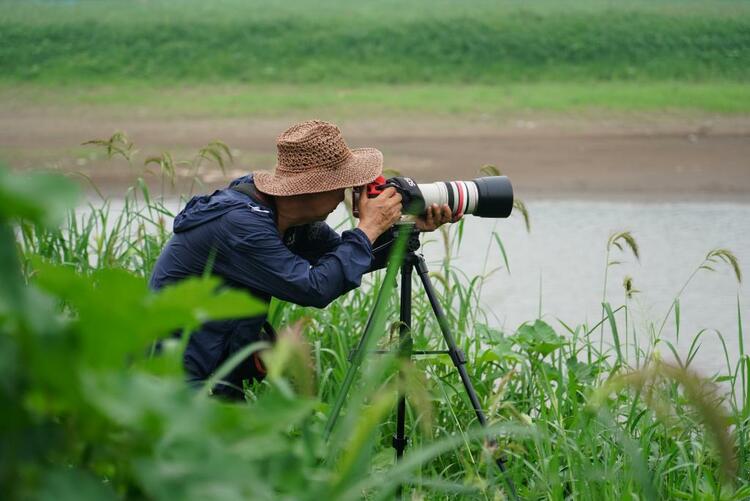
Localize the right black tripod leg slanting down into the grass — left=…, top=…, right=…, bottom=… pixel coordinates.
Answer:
left=414, top=254, right=518, bottom=499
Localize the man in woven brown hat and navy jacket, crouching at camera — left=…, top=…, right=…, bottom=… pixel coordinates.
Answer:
left=149, top=120, right=451, bottom=398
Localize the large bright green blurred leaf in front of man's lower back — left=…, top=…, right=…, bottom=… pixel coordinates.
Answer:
left=36, top=262, right=265, bottom=367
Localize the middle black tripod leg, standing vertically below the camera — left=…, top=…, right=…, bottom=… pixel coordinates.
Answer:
left=393, top=257, right=413, bottom=499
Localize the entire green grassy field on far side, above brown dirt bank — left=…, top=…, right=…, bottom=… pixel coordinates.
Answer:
left=0, top=0, right=750, bottom=116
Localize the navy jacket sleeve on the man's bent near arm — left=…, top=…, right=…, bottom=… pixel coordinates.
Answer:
left=222, top=211, right=372, bottom=308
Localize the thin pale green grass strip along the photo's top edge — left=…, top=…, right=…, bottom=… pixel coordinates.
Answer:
left=1, top=0, right=750, bottom=25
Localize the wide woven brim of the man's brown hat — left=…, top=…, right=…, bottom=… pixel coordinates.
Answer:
left=253, top=148, right=383, bottom=196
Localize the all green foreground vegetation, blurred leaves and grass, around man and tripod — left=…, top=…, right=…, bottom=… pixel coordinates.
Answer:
left=0, top=138, right=750, bottom=500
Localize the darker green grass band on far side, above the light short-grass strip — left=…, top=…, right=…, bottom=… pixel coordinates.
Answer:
left=0, top=0, right=750, bottom=85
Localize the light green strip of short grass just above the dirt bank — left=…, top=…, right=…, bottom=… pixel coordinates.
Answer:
left=5, top=82, right=750, bottom=118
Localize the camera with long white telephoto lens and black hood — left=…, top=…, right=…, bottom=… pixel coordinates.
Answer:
left=352, top=176, right=513, bottom=218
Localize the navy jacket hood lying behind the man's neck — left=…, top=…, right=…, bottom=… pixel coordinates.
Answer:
left=173, top=175, right=273, bottom=233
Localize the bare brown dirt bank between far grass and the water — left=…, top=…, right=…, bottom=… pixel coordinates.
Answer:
left=0, top=109, right=750, bottom=201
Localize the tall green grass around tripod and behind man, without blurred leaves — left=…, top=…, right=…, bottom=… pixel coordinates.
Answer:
left=4, top=135, right=750, bottom=500
